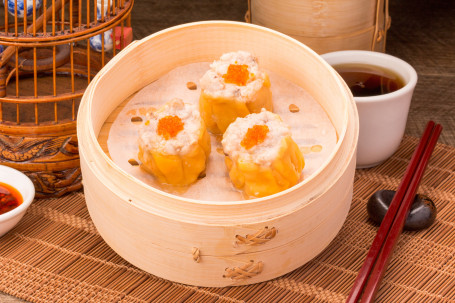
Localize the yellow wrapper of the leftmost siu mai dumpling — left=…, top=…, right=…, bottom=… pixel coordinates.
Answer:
left=138, top=100, right=211, bottom=186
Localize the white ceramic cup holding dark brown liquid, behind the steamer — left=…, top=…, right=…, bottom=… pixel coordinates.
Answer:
left=322, top=50, right=417, bottom=168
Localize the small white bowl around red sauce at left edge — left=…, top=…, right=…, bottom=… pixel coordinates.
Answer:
left=0, top=165, right=35, bottom=237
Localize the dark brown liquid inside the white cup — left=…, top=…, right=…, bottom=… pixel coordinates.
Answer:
left=333, top=63, right=405, bottom=97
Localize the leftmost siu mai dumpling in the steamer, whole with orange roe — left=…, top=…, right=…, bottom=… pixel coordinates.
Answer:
left=138, top=99, right=210, bottom=185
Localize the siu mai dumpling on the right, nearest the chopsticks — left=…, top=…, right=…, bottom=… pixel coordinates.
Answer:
left=222, top=110, right=305, bottom=197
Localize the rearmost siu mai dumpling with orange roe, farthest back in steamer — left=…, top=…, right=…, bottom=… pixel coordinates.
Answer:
left=199, top=51, right=272, bottom=134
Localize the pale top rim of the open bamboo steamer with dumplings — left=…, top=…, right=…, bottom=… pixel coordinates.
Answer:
left=77, top=20, right=357, bottom=211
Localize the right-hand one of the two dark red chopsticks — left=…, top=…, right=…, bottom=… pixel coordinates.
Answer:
left=360, top=124, right=442, bottom=303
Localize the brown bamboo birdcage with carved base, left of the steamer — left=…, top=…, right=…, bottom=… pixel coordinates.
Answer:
left=0, top=0, right=133, bottom=197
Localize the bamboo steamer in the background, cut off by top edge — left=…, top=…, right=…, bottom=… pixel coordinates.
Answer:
left=245, top=0, right=391, bottom=54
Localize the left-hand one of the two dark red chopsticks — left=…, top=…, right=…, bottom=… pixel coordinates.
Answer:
left=346, top=121, right=440, bottom=303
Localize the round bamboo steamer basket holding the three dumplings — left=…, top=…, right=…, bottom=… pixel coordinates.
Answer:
left=77, top=21, right=364, bottom=287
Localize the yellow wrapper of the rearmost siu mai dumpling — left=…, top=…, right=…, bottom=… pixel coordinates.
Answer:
left=199, top=76, right=273, bottom=134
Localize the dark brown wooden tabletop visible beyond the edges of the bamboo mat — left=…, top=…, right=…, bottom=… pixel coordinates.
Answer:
left=0, top=0, right=455, bottom=303
